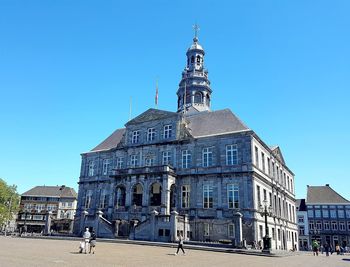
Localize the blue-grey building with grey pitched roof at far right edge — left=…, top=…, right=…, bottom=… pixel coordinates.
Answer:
left=306, top=184, right=350, bottom=247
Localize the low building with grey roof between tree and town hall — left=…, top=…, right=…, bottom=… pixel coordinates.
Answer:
left=17, top=185, right=77, bottom=233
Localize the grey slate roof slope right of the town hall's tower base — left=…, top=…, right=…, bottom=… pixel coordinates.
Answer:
left=186, top=109, right=250, bottom=137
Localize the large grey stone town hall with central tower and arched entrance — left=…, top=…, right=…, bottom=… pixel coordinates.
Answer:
left=74, top=31, right=298, bottom=250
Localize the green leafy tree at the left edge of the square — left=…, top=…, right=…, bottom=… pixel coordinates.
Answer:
left=0, top=178, right=20, bottom=229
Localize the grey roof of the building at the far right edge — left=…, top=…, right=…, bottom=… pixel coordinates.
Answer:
left=306, top=185, right=350, bottom=204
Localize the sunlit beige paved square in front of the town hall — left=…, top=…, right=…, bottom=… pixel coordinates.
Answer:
left=0, top=237, right=350, bottom=267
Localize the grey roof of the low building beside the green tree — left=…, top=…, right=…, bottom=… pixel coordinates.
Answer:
left=22, top=185, right=77, bottom=198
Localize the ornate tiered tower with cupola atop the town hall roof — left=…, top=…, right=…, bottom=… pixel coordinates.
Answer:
left=177, top=25, right=212, bottom=113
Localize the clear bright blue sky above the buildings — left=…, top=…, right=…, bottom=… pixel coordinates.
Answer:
left=0, top=0, right=350, bottom=199
